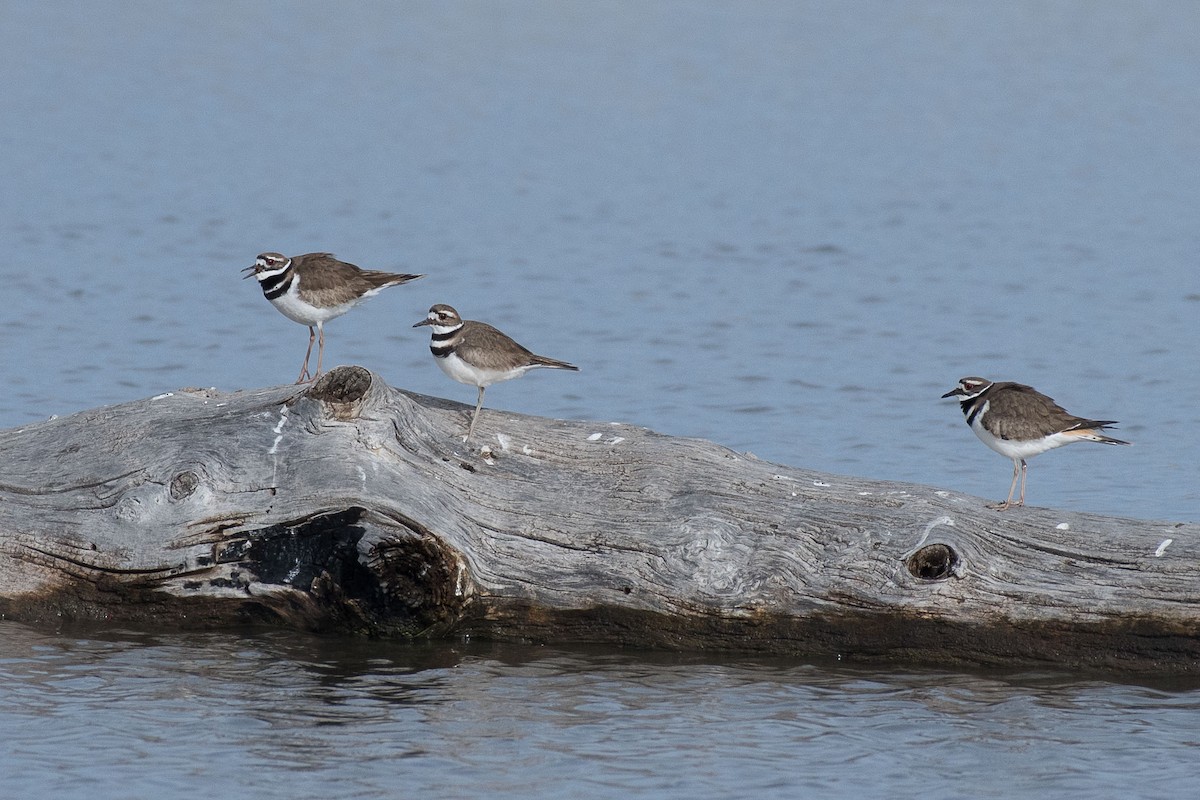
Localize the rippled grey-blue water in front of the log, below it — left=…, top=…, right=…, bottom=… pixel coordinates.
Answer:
left=0, top=622, right=1200, bottom=800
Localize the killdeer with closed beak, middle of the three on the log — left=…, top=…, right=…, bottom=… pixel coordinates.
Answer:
left=413, top=303, right=578, bottom=441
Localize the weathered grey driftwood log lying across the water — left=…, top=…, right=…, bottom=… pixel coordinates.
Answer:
left=0, top=367, right=1200, bottom=673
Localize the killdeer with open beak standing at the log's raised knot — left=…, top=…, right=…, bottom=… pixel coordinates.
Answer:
left=242, top=253, right=424, bottom=384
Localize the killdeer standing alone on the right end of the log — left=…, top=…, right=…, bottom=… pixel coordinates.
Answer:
left=942, top=378, right=1129, bottom=510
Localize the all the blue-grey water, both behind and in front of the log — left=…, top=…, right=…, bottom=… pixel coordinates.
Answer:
left=0, top=0, right=1200, bottom=798
